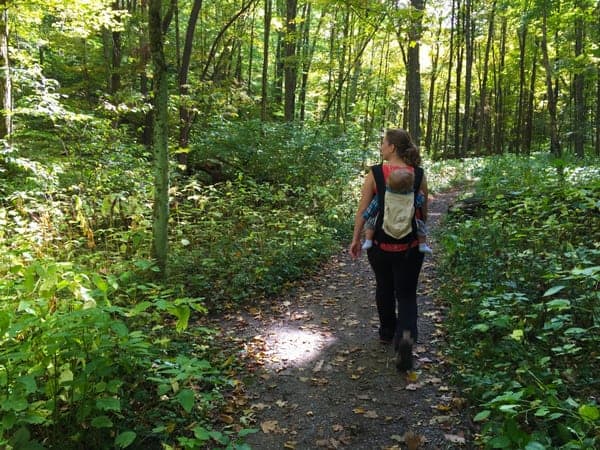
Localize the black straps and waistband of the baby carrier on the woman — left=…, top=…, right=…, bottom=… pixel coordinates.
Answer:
left=371, top=164, right=424, bottom=251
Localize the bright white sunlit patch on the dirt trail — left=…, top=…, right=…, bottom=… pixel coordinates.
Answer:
left=265, top=326, right=336, bottom=368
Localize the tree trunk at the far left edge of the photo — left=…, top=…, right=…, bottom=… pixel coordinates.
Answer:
left=0, top=0, right=12, bottom=139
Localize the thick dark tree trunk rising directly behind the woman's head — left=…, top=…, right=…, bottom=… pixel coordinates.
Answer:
left=406, top=0, right=425, bottom=145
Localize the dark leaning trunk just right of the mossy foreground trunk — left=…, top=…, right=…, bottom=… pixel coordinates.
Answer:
left=177, top=0, right=202, bottom=166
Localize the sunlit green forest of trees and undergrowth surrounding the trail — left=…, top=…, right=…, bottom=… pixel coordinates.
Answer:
left=0, top=0, right=600, bottom=450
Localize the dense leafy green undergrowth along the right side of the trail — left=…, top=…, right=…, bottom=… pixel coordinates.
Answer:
left=442, top=155, right=600, bottom=449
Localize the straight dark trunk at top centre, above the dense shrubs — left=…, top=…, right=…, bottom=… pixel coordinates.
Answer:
left=283, top=0, right=298, bottom=122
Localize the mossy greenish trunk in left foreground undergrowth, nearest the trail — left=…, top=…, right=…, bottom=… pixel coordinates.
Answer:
left=148, top=0, right=169, bottom=278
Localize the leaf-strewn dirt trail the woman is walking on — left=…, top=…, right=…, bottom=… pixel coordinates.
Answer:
left=216, top=192, right=472, bottom=450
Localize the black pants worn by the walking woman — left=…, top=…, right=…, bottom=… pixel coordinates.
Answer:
left=368, top=247, right=424, bottom=342
